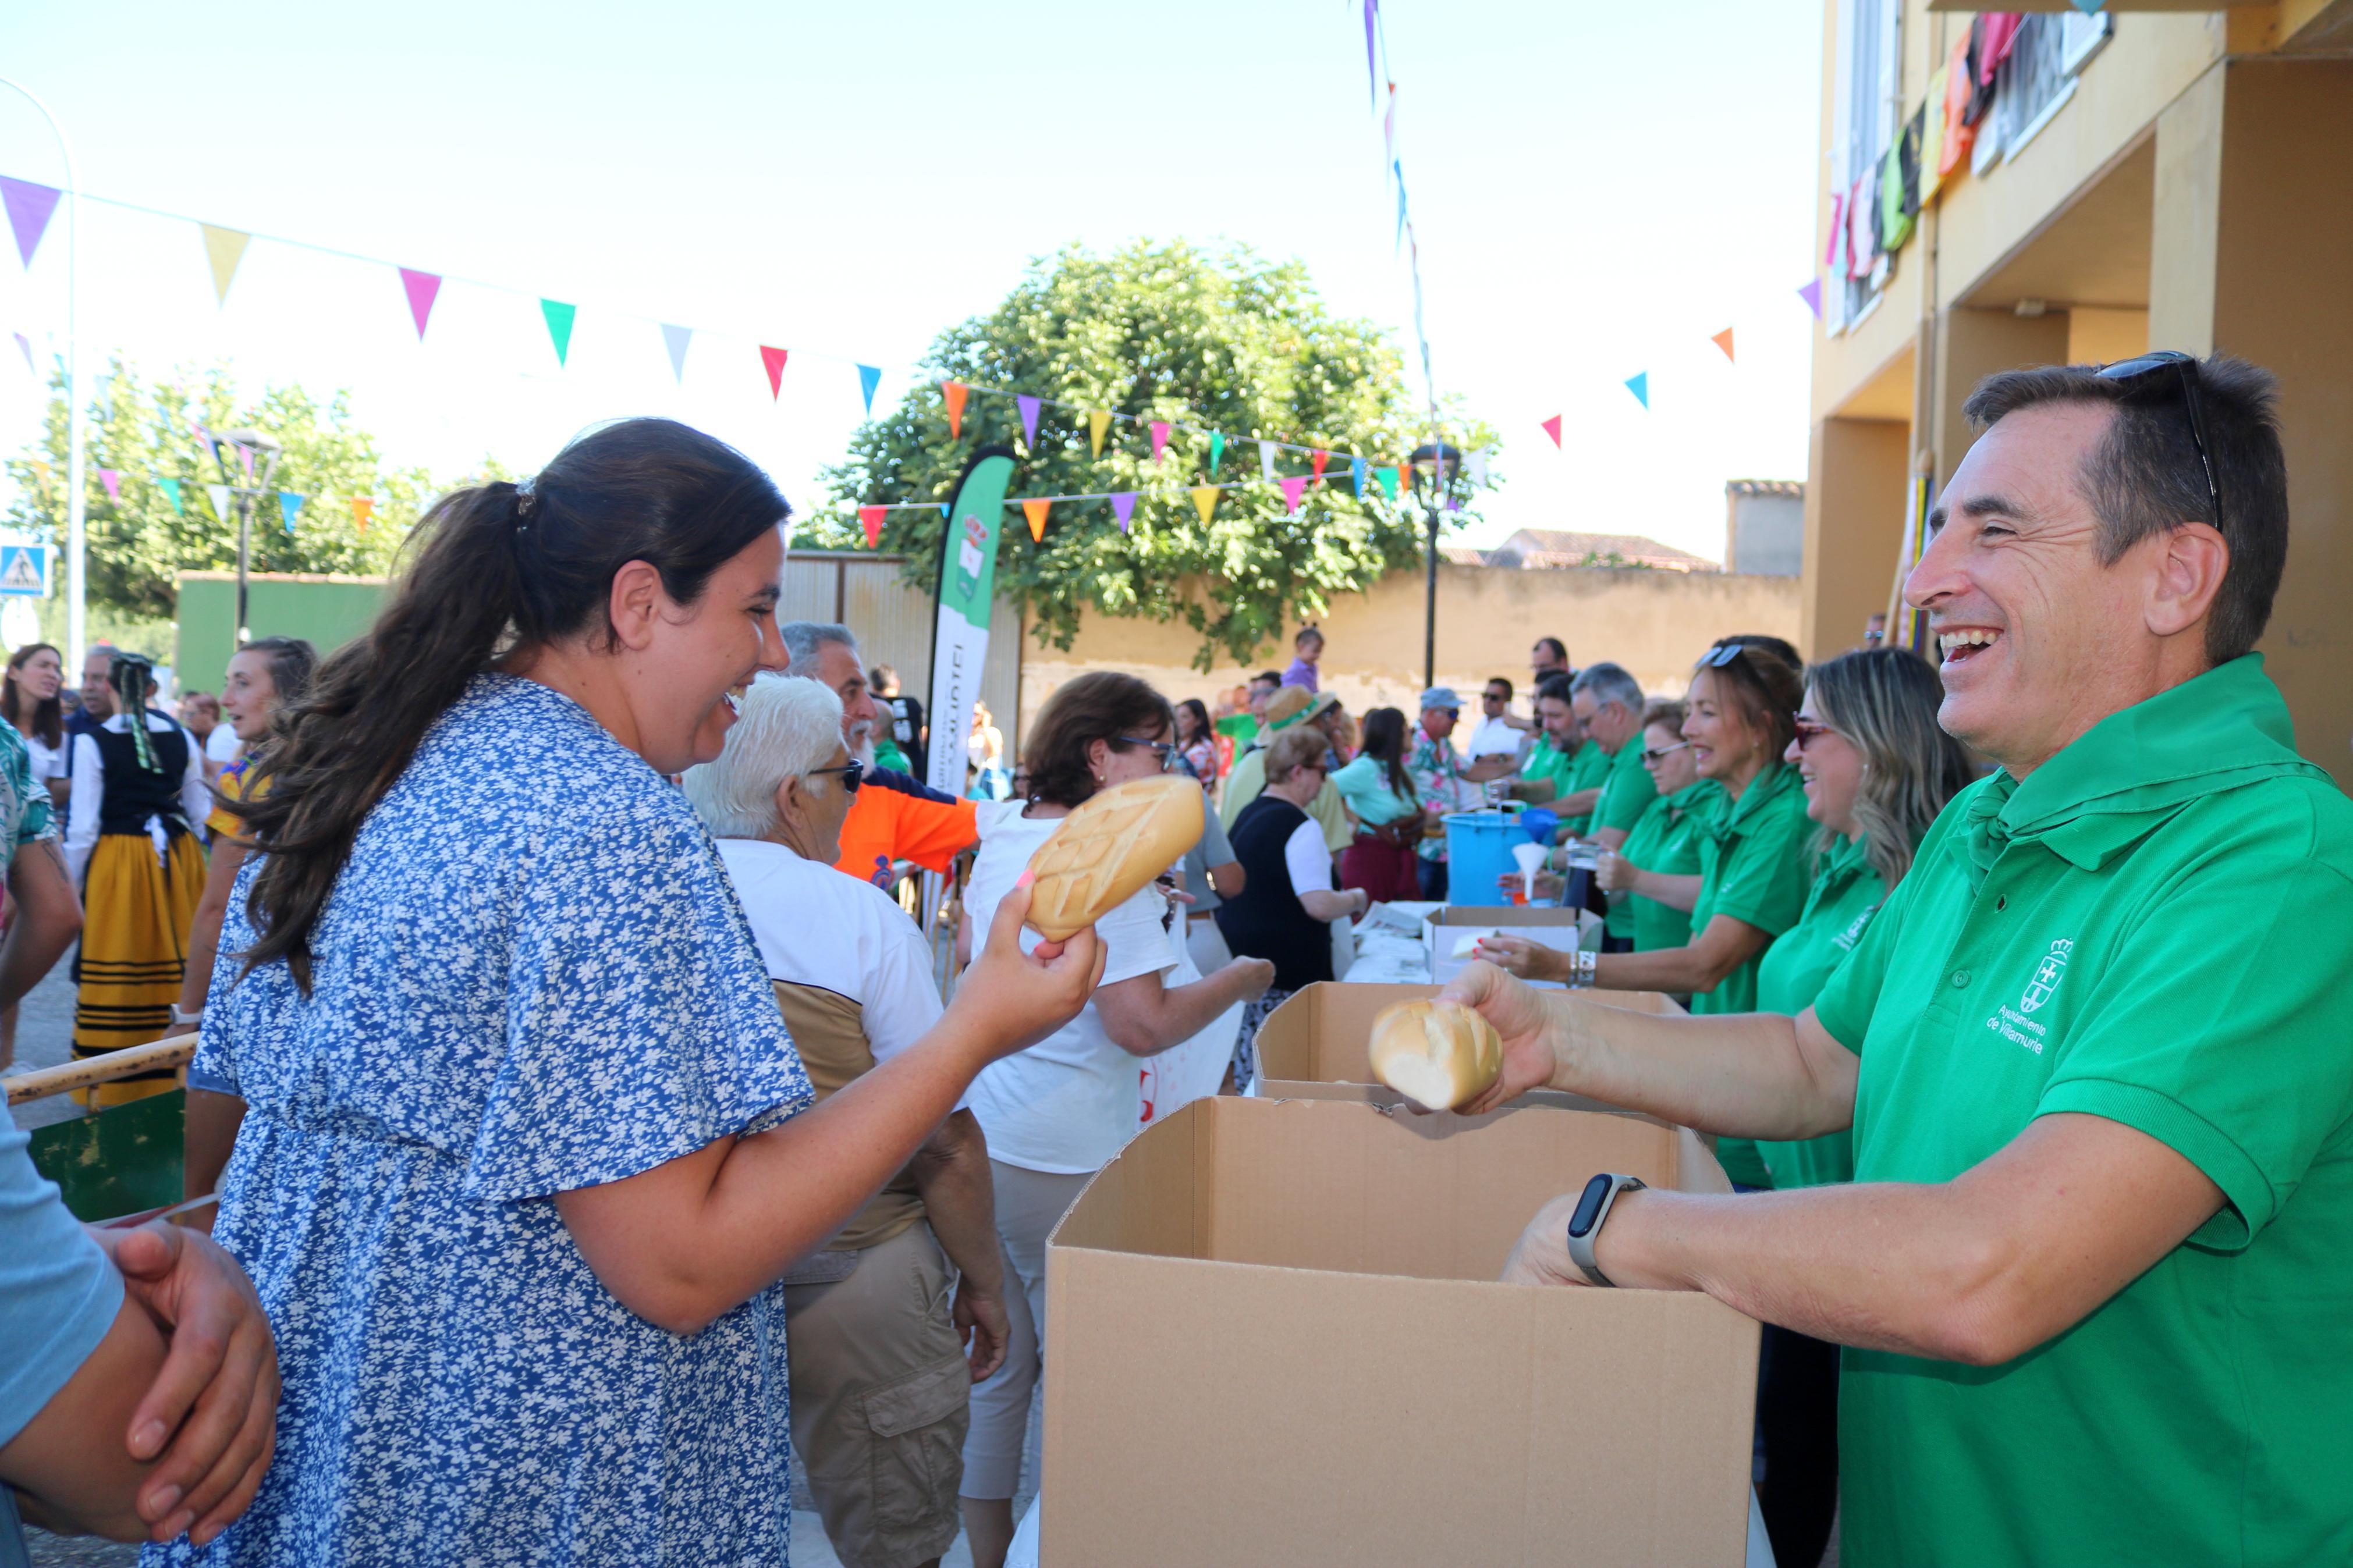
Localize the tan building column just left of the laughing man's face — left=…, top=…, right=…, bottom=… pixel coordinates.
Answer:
left=1798, top=418, right=1911, bottom=660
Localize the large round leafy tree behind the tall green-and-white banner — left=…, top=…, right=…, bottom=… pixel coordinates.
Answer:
left=805, top=242, right=1494, bottom=670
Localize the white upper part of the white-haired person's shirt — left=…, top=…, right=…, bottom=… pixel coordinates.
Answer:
left=718, top=839, right=941, bottom=1065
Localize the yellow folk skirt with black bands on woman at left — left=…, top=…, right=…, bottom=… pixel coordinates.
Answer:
left=73, top=832, right=205, bottom=1107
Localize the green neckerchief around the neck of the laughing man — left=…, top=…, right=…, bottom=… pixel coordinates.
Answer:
left=1955, top=653, right=2327, bottom=888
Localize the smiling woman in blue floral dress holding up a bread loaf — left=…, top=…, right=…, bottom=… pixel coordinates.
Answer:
left=161, top=421, right=1099, bottom=1568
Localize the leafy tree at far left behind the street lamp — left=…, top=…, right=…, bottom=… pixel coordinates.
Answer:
left=9, top=360, right=499, bottom=621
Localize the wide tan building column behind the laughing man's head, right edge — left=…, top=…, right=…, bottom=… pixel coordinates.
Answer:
left=2148, top=56, right=2353, bottom=788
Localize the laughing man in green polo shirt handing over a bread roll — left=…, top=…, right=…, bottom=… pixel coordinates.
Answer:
left=1447, top=355, right=2353, bottom=1568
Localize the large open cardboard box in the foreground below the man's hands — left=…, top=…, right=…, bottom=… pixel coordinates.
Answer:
left=1040, top=1096, right=1758, bottom=1568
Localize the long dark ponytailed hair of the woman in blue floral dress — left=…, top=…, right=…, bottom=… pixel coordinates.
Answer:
left=233, top=418, right=790, bottom=992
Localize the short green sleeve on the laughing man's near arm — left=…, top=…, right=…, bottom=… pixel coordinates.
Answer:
left=2035, top=834, right=2353, bottom=1253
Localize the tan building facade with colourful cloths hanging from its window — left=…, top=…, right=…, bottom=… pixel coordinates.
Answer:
left=1800, top=0, right=2353, bottom=785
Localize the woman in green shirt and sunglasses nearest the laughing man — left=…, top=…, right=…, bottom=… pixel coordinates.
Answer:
left=1751, top=649, right=1976, bottom=1563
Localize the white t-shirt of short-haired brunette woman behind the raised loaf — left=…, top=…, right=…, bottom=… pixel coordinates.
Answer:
left=965, top=802, right=1181, bottom=1175
